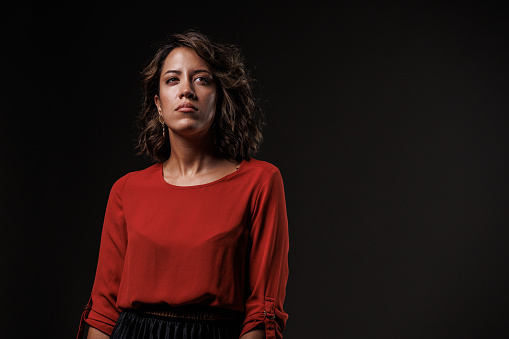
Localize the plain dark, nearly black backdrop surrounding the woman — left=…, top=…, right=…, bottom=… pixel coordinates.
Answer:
left=0, top=2, right=509, bottom=338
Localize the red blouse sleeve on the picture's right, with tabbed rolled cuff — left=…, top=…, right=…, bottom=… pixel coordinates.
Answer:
left=241, top=168, right=289, bottom=339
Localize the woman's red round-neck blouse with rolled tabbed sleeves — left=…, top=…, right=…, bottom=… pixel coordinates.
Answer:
left=84, top=159, right=288, bottom=339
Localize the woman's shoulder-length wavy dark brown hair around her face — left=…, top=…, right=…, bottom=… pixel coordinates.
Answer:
left=137, top=32, right=262, bottom=162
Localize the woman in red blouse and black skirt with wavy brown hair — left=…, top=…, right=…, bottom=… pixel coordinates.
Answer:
left=80, top=32, right=288, bottom=339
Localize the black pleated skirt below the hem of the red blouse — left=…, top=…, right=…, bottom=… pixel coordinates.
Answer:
left=110, top=310, right=242, bottom=339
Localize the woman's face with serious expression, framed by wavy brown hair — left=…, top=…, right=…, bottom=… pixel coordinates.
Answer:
left=154, top=47, right=217, bottom=137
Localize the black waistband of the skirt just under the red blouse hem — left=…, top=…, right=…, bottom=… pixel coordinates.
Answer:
left=138, top=304, right=245, bottom=321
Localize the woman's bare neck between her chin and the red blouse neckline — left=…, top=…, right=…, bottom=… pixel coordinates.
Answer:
left=163, top=132, right=220, bottom=176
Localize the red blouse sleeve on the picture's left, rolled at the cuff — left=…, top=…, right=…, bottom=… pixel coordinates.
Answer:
left=85, top=175, right=128, bottom=335
